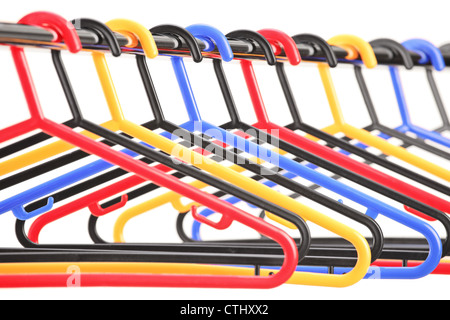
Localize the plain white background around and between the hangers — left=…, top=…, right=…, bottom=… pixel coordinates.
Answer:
left=0, top=0, right=450, bottom=299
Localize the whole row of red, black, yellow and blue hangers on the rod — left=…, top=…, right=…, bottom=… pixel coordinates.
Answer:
left=0, top=12, right=450, bottom=288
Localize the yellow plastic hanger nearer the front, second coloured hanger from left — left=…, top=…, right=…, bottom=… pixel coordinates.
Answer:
left=0, top=20, right=371, bottom=287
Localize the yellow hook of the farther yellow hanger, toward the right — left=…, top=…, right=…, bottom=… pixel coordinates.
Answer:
left=328, top=34, right=378, bottom=69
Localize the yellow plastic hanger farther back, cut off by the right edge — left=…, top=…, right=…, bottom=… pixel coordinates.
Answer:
left=308, top=35, right=450, bottom=181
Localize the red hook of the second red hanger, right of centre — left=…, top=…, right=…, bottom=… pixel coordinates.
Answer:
left=258, top=29, right=302, bottom=66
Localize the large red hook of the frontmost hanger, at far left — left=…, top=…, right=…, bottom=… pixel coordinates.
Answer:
left=18, top=11, right=82, bottom=53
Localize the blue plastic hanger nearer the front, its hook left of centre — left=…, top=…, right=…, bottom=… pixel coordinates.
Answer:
left=167, top=25, right=442, bottom=279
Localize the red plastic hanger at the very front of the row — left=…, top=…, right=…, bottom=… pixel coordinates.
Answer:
left=0, top=12, right=298, bottom=288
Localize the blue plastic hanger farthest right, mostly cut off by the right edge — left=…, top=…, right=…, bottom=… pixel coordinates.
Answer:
left=389, top=39, right=450, bottom=148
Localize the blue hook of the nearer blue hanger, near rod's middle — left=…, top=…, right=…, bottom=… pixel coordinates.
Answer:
left=186, top=24, right=234, bottom=62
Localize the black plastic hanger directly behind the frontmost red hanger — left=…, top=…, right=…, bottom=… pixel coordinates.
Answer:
left=12, top=19, right=316, bottom=272
